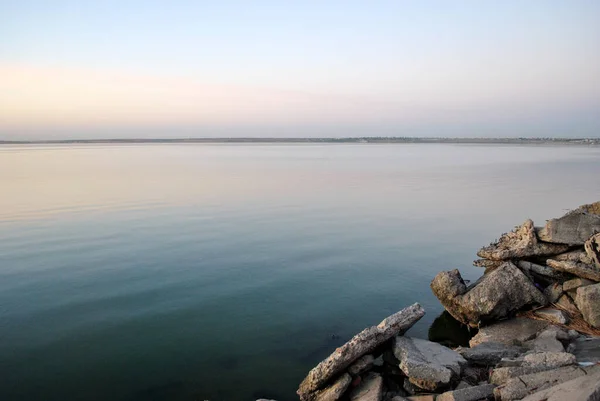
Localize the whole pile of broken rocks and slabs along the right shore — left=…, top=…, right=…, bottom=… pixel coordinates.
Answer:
left=258, top=202, right=600, bottom=401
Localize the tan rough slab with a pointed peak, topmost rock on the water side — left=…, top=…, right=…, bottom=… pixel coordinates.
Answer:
left=477, top=220, right=569, bottom=260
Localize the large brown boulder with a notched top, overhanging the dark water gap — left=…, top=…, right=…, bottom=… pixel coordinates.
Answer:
left=431, top=262, right=547, bottom=327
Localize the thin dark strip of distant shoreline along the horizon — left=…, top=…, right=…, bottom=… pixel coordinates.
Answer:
left=0, top=137, right=600, bottom=145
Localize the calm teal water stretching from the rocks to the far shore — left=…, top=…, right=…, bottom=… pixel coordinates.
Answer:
left=0, top=144, right=600, bottom=401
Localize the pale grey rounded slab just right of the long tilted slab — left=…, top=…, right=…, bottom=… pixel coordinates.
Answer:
left=394, top=337, right=467, bottom=391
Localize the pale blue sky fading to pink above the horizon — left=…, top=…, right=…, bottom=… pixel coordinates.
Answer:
left=0, top=0, right=600, bottom=140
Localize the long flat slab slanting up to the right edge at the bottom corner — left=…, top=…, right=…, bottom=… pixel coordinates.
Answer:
left=494, top=366, right=598, bottom=401
